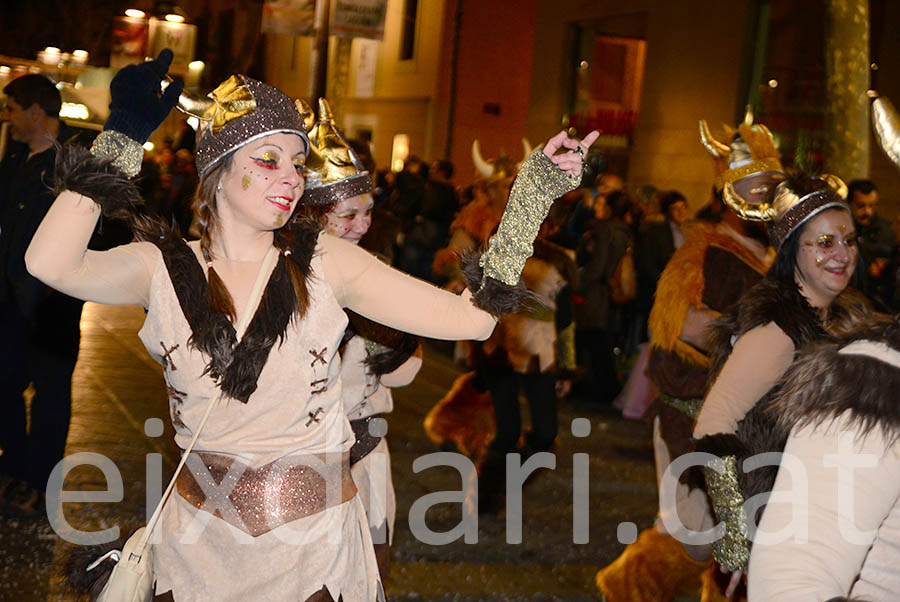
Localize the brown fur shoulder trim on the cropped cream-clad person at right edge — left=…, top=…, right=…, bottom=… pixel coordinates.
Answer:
left=769, top=318, right=900, bottom=442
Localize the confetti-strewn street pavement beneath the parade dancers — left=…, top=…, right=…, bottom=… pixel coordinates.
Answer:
left=0, top=303, right=668, bottom=602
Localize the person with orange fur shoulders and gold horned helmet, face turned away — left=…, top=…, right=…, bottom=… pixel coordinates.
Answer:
left=596, top=122, right=781, bottom=602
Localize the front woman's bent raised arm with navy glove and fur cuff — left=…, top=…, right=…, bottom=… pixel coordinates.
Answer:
left=25, top=50, right=183, bottom=306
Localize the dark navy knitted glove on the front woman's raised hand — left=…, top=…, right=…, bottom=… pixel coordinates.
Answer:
left=103, top=48, right=184, bottom=144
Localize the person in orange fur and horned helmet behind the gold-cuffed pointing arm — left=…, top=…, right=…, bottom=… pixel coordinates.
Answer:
left=425, top=142, right=576, bottom=506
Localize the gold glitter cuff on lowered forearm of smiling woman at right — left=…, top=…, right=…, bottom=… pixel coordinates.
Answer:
left=703, top=456, right=750, bottom=571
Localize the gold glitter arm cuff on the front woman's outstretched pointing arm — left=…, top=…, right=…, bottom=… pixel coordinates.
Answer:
left=479, top=149, right=581, bottom=286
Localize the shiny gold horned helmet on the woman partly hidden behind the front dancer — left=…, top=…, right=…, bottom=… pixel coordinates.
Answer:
left=299, top=98, right=372, bottom=205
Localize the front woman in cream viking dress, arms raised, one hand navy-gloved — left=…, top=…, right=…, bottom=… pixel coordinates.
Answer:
left=26, top=51, right=596, bottom=602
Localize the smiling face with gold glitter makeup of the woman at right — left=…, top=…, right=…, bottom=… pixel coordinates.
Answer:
left=797, top=209, right=858, bottom=307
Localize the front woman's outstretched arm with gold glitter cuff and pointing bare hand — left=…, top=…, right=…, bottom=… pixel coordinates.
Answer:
left=321, top=132, right=598, bottom=340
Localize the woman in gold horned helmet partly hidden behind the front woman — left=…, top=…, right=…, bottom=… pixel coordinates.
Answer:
left=301, top=98, right=422, bottom=579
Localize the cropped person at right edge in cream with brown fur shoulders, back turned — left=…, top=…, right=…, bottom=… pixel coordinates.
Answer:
left=747, top=91, right=900, bottom=602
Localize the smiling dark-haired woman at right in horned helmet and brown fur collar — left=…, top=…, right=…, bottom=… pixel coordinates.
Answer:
left=694, top=170, right=868, bottom=593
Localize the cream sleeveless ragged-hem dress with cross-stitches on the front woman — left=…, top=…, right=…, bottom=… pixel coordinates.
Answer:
left=140, top=243, right=384, bottom=602
